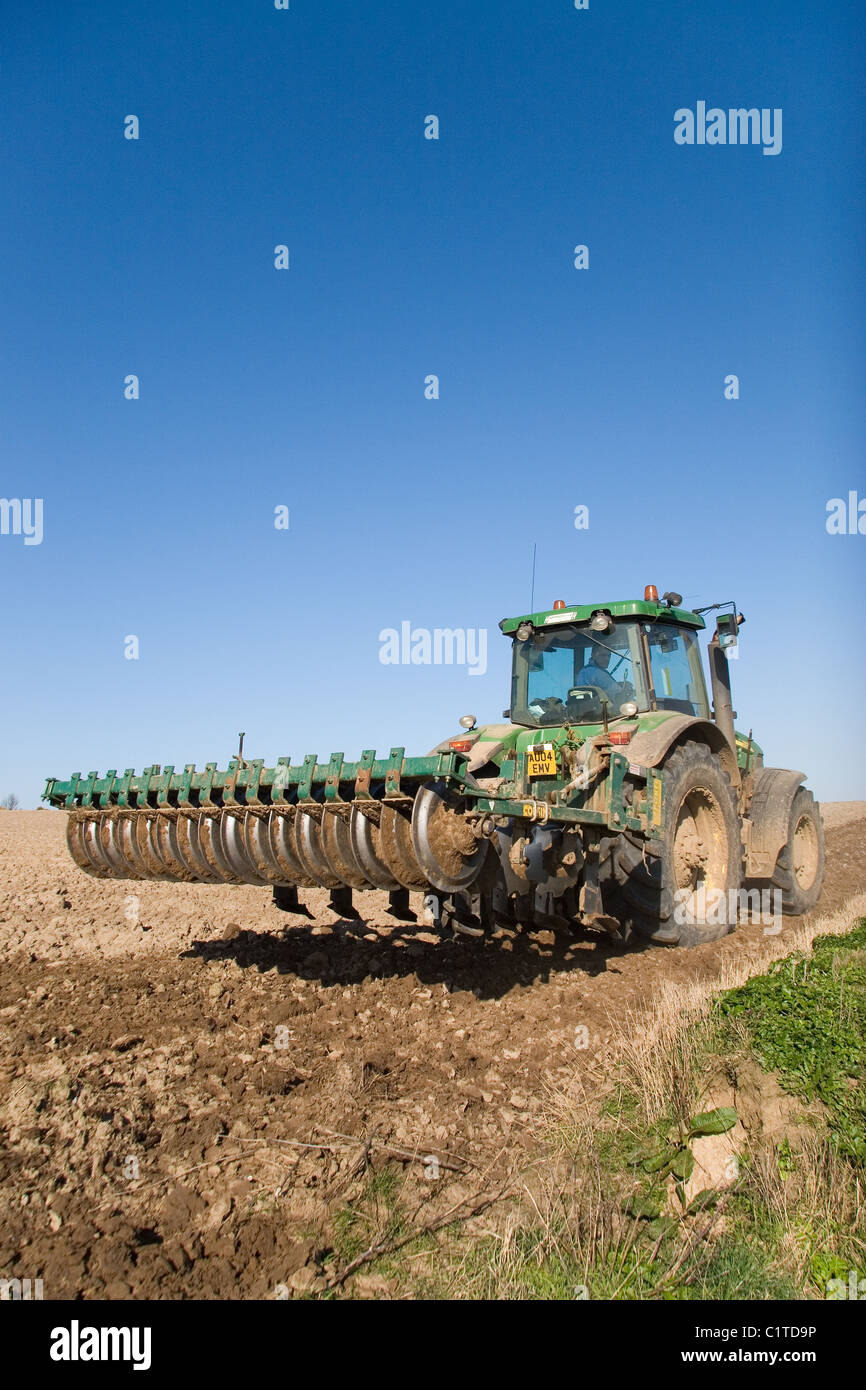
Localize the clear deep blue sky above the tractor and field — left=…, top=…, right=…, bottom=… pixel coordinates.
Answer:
left=0, top=0, right=866, bottom=805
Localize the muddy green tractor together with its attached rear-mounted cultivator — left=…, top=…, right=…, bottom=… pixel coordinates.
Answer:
left=43, top=585, right=824, bottom=945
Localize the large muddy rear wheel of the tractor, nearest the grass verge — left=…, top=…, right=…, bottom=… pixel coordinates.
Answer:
left=605, top=742, right=742, bottom=947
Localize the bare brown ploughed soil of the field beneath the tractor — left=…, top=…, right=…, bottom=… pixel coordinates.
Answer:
left=0, top=802, right=866, bottom=1298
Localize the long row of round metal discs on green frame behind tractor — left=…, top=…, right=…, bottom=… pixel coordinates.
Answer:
left=46, top=749, right=488, bottom=892
